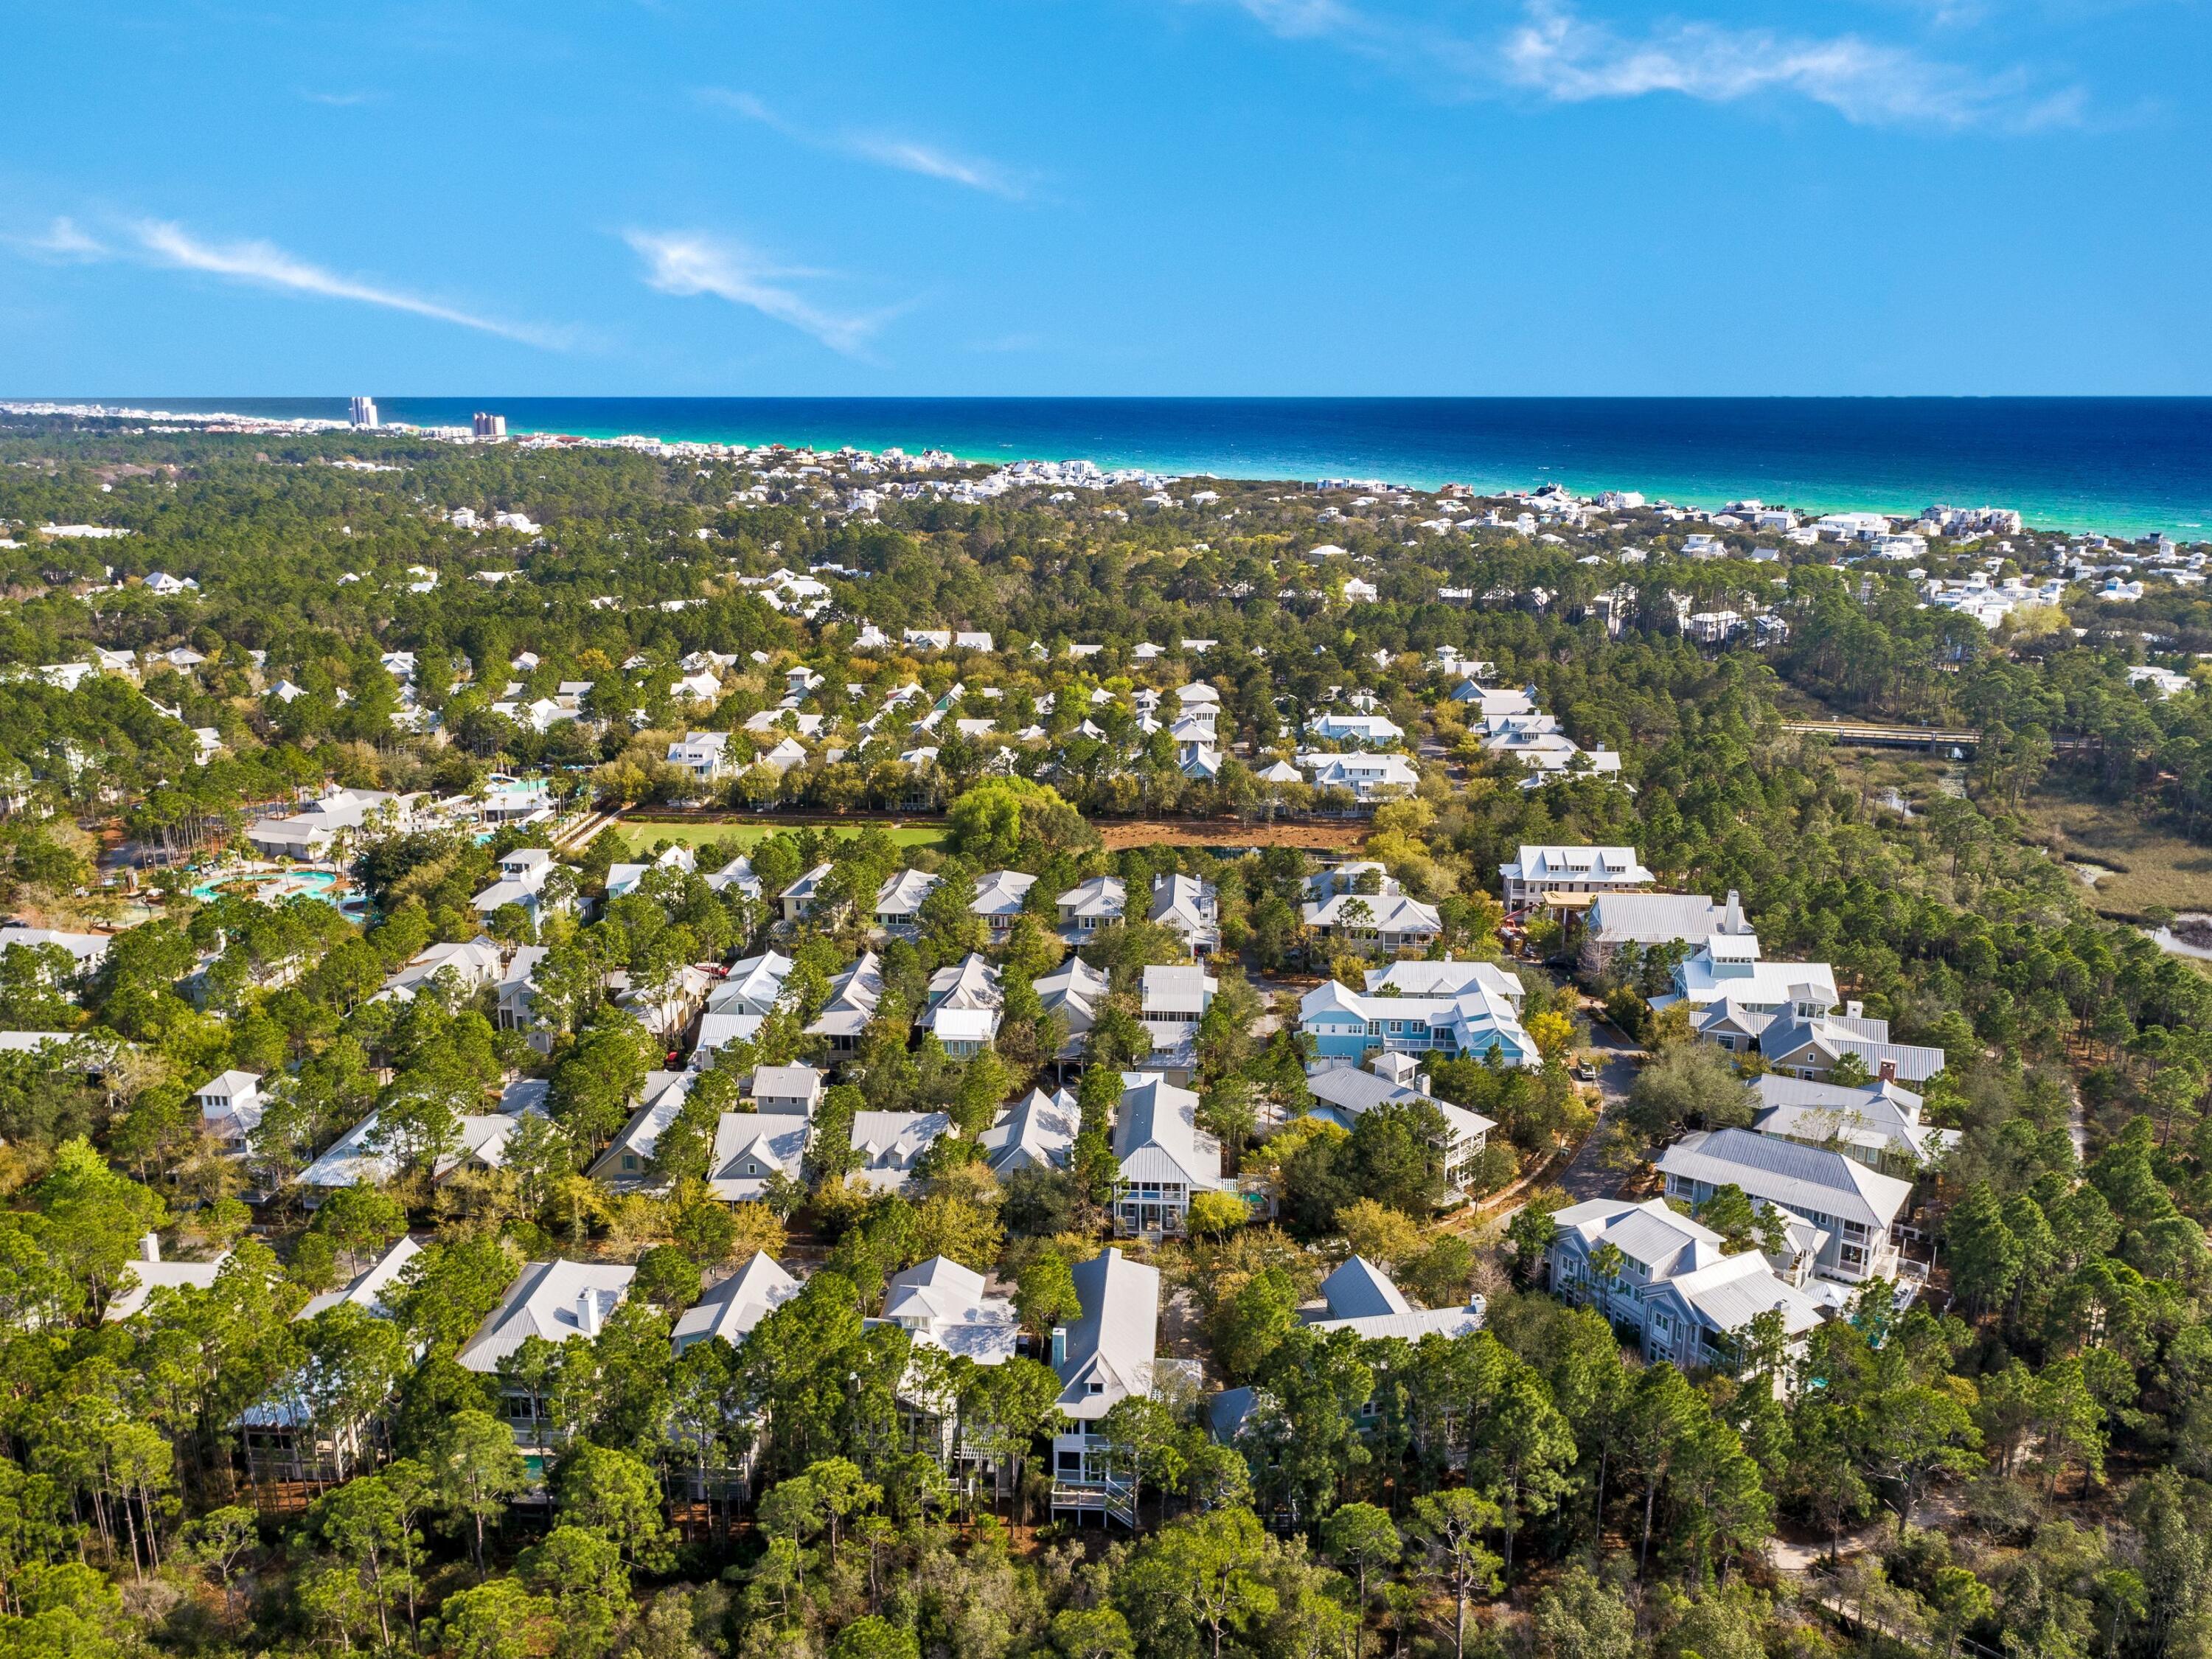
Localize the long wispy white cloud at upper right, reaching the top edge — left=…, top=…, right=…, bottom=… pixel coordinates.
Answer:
left=1201, top=0, right=2081, bottom=131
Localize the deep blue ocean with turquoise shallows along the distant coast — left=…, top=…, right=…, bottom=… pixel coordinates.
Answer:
left=69, top=394, right=2212, bottom=540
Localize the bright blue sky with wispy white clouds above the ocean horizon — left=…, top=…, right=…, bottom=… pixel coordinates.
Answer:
left=0, top=0, right=2212, bottom=396
